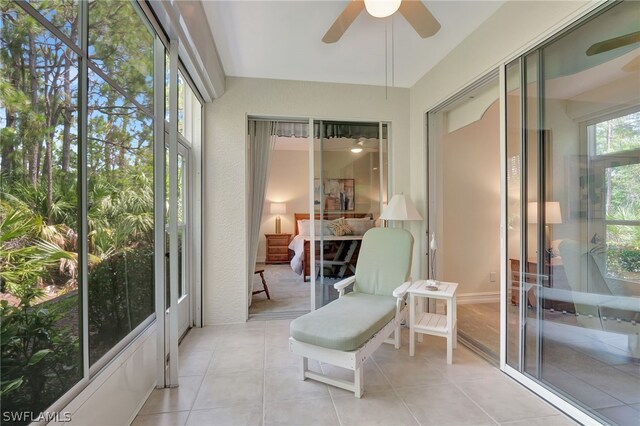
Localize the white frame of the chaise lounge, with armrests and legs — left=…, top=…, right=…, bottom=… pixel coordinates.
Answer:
left=289, top=276, right=412, bottom=398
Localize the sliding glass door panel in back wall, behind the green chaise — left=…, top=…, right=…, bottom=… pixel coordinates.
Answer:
left=305, top=121, right=389, bottom=309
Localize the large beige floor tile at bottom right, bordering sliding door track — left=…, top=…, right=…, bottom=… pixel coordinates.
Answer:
left=456, top=375, right=559, bottom=422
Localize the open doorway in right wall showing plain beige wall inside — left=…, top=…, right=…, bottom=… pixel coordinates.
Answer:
left=427, top=73, right=500, bottom=364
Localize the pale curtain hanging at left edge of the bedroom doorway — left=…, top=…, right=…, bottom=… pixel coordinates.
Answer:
left=247, top=120, right=278, bottom=306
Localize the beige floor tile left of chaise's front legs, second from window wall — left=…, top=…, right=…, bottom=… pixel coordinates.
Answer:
left=193, top=370, right=264, bottom=410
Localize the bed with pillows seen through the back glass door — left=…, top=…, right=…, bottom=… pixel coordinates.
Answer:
left=289, top=212, right=374, bottom=281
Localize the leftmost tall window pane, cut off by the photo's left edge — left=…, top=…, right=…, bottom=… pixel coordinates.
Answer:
left=0, top=1, right=83, bottom=424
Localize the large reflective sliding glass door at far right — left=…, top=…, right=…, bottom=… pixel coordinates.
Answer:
left=504, top=1, right=640, bottom=424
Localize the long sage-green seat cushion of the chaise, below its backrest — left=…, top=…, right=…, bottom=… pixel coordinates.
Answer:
left=291, top=292, right=396, bottom=351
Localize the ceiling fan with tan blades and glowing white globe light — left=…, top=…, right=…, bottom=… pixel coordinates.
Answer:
left=322, top=0, right=440, bottom=43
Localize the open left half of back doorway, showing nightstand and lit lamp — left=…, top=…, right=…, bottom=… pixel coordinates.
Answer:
left=249, top=120, right=311, bottom=319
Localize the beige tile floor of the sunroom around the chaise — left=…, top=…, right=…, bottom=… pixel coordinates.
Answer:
left=133, top=320, right=575, bottom=426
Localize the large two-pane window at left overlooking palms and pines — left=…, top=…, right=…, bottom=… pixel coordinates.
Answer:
left=0, top=0, right=156, bottom=424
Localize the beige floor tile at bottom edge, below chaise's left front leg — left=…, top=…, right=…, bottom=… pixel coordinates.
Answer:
left=264, top=398, right=339, bottom=426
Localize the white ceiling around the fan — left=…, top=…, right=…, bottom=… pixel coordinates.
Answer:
left=203, top=0, right=504, bottom=87
